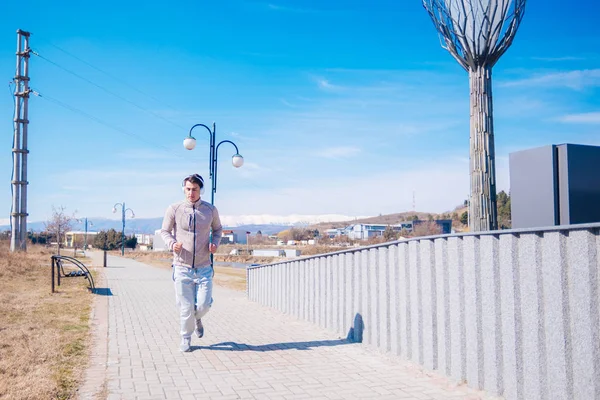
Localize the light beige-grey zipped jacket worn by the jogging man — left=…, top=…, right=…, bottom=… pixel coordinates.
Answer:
left=160, top=200, right=223, bottom=268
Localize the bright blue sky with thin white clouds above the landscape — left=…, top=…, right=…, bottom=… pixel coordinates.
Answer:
left=0, top=0, right=600, bottom=224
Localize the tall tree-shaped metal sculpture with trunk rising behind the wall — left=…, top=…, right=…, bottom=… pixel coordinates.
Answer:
left=423, top=0, right=526, bottom=231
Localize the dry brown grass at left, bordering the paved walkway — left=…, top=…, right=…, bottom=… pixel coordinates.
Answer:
left=0, top=242, right=92, bottom=399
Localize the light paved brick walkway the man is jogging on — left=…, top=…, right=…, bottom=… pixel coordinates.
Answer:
left=79, top=252, right=496, bottom=400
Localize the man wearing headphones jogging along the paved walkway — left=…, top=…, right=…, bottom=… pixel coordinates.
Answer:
left=160, top=174, right=223, bottom=352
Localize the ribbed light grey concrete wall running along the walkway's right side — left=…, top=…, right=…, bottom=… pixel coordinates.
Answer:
left=247, top=224, right=600, bottom=400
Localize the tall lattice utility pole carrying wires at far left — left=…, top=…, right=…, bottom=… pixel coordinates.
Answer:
left=10, top=29, right=31, bottom=251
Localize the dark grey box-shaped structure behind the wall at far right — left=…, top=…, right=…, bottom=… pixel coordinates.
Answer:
left=509, top=144, right=600, bottom=228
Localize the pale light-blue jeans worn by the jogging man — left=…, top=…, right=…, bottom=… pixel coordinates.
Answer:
left=173, top=266, right=213, bottom=338
